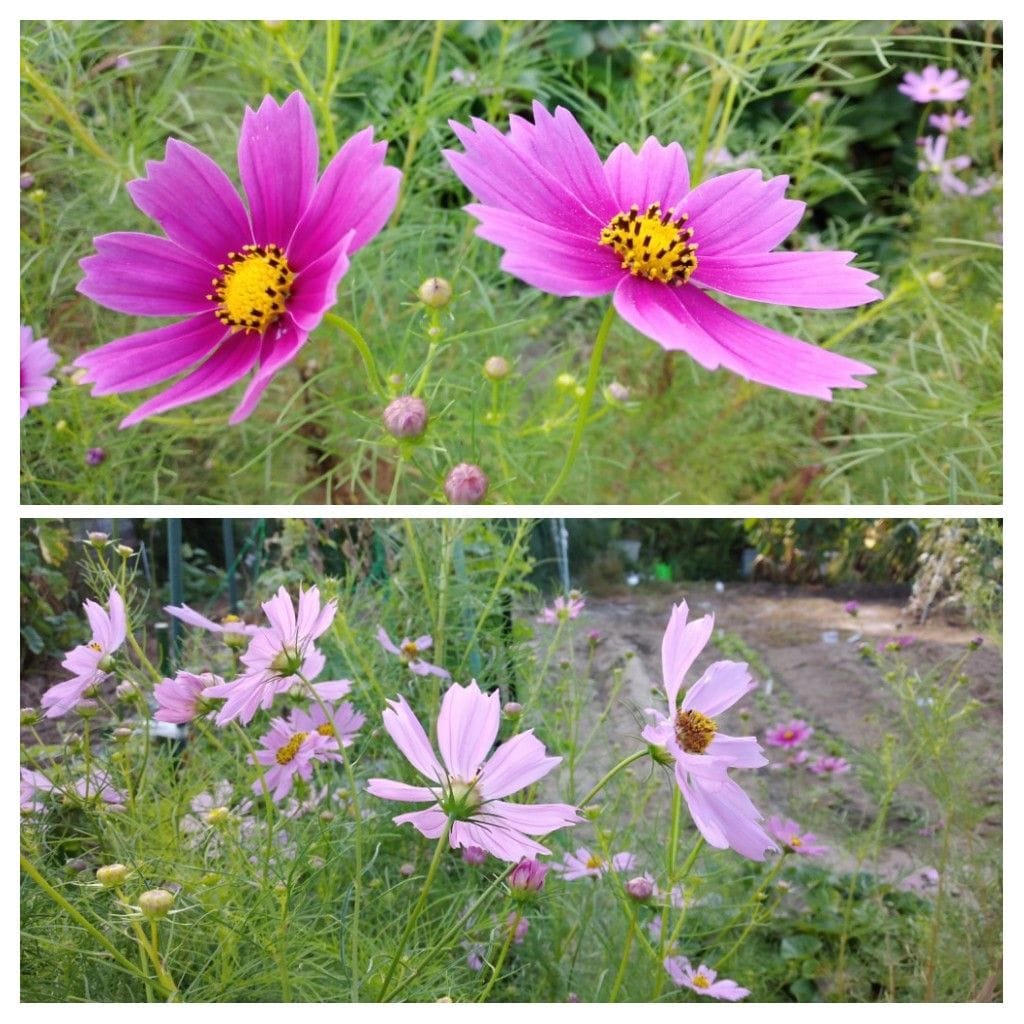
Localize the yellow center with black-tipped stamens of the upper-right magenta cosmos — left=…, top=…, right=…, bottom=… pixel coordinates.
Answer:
left=601, top=203, right=697, bottom=285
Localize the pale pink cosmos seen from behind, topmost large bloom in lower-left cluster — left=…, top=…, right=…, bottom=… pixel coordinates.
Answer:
left=203, top=587, right=351, bottom=725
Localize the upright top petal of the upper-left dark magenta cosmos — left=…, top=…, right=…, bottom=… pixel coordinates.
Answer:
left=239, top=92, right=319, bottom=249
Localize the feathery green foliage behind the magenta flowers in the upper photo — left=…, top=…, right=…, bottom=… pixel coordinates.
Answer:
left=22, top=22, right=1001, bottom=504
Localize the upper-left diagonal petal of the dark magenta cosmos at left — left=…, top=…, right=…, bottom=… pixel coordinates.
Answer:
left=127, top=138, right=253, bottom=266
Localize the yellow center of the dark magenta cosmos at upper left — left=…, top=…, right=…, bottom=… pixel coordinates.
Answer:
left=207, top=246, right=295, bottom=334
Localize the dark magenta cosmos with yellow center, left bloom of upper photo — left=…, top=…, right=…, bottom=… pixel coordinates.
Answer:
left=75, top=92, right=401, bottom=427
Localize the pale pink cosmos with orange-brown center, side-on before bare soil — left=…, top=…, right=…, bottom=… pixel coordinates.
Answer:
left=642, top=601, right=777, bottom=860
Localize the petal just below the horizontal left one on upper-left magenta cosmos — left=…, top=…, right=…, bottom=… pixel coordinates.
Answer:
left=75, top=312, right=229, bottom=396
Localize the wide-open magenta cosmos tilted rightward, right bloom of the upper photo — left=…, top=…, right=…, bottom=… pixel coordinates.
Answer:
left=444, top=103, right=880, bottom=398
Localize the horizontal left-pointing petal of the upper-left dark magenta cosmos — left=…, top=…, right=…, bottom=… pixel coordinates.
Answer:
left=77, top=231, right=216, bottom=316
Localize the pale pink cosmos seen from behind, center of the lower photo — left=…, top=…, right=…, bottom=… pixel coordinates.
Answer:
left=367, top=681, right=581, bottom=861
